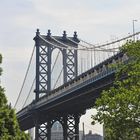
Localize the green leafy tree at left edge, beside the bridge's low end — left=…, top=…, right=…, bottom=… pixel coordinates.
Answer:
left=0, top=54, right=29, bottom=140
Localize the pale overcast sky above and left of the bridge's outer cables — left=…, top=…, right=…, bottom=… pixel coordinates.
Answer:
left=0, top=0, right=140, bottom=135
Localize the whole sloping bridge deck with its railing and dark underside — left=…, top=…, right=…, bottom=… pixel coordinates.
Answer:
left=17, top=53, right=127, bottom=130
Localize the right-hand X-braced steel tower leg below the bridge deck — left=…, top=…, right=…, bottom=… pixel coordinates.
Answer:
left=63, top=114, right=81, bottom=140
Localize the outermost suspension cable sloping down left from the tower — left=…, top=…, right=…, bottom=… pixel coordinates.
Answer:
left=14, top=46, right=35, bottom=108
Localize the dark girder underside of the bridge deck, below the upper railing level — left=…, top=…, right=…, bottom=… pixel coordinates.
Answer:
left=17, top=72, right=114, bottom=130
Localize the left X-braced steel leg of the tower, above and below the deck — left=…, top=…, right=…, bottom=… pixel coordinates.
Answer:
left=34, top=29, right=52, bottom=140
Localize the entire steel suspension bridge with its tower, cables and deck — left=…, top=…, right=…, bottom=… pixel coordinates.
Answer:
left=14, top=29, right=140, bottom=140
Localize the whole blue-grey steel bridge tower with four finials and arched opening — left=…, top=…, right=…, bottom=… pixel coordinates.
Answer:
left=34, top=29, right=81, bottom=140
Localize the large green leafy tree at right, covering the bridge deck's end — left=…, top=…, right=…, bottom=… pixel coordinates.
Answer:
left=92, top=41, right=140, bottom=140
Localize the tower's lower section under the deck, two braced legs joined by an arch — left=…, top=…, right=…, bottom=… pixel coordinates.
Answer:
left=35, top=113, right=81, bottom=140
